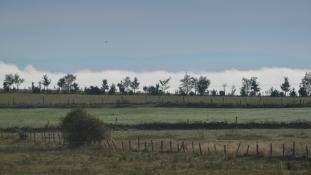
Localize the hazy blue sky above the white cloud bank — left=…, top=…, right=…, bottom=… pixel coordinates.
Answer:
left=0, top=0, right=311, bottom=91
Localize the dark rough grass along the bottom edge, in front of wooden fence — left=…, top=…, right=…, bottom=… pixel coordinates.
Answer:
left=0, top=148, right=311, bottom=175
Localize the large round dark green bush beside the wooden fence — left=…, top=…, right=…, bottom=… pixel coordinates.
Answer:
left=60, top=109, right=109, bottom=147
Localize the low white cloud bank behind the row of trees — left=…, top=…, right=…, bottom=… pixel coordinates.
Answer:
left=0, top=61, right=310, bottom=92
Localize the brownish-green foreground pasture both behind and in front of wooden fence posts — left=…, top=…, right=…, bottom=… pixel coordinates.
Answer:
left=0, top=129, right=311, bottom=175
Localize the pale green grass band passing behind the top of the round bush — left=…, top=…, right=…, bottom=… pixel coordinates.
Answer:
left=0, top=107, right=311, bottom=128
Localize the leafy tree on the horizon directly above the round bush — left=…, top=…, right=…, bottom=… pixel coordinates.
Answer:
left=57, top=74, right=79, bottom=93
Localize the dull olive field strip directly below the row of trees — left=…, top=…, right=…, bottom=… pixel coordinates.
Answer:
left=0, top=93, right=311, bottom=108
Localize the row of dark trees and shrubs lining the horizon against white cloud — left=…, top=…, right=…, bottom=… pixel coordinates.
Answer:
left=3, top=72, right=311, bottom=97
